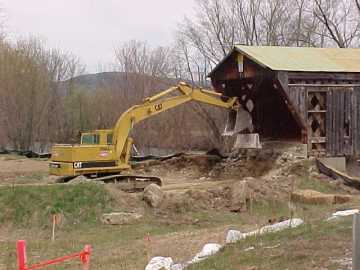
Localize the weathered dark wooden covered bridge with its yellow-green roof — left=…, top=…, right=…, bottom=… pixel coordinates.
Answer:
left=209, top=45, right=360, bottom=157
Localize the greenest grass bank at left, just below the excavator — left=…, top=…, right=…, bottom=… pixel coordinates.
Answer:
left=0, top=184, right=111, bottom=227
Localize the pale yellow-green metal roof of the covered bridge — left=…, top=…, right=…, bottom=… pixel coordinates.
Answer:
left=234, top=45, right=360, bottom=72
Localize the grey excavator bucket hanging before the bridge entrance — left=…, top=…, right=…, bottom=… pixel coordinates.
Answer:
left=222, top=107, right=261, bottom=149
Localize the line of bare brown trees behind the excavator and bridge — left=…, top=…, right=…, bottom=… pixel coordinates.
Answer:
left=0, top=0, right=360, bottom=150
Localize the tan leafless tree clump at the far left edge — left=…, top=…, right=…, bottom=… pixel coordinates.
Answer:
left=0, top=35, right=84, bottom=150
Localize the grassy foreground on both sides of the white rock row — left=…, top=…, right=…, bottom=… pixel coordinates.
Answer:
left=0, top=184, right=351, bottom=270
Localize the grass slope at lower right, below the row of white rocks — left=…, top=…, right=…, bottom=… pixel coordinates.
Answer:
left=189, top=218, right=351, bottom=270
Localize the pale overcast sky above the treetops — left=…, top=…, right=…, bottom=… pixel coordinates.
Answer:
left=0, top=0, right=194, bottom=72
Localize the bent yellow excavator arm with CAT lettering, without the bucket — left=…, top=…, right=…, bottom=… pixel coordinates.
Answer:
left=113, top=83, right=239, bottom=159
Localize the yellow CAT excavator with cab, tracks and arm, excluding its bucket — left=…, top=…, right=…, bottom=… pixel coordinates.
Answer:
left=49, top=83, right=239, bottom=191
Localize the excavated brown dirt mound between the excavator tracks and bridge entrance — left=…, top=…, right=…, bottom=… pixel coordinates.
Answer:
left=137, top=150, right=353, bottom=215
